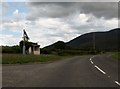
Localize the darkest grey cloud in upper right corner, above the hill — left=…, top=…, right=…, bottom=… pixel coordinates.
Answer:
left=78, top=2, right=118, bottom=19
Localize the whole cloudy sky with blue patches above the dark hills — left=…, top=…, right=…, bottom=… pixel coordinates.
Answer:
left=0, top=0, right=118, bottom=48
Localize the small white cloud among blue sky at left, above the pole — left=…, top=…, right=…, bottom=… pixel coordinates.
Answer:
left=2, top=9, right=30, bottom=32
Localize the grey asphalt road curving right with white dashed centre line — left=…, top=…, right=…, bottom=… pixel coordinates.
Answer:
left=2, top=55, right=119, bottom=87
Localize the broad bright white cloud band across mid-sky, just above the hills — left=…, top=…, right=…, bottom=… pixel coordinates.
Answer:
left=2, top=11, right=117, bottom=47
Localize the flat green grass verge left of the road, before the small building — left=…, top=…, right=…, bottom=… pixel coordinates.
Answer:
left=2, top=54, right=69, bottom=64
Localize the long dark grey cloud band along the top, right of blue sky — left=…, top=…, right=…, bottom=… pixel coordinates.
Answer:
left=28, top=2, right=118, bottom=20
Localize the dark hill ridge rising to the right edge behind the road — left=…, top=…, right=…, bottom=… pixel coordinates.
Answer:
left=44, top=28, right=120, bottom=51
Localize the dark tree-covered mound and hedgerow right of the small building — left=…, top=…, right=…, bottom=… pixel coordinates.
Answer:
left=41, top=41, right=100, bottom=56
